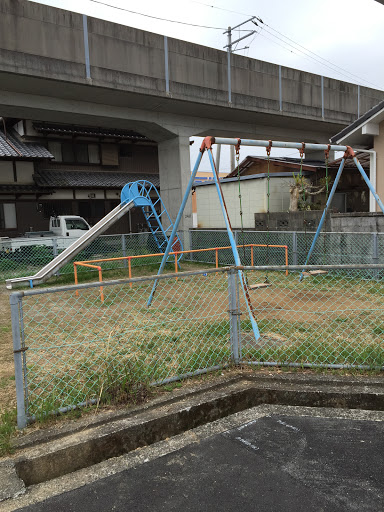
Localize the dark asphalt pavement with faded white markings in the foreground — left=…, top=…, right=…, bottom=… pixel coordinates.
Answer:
left=18, top=414, right=384, bottom=512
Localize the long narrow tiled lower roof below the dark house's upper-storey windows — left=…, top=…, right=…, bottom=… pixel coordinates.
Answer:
left=33, top=170, right=160, bottom=189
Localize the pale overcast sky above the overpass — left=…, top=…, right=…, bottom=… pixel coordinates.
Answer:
left=29, top=0, right=384, bottom=168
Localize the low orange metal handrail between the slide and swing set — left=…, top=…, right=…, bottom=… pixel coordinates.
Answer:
left=73, top=244, right=288, bottom=296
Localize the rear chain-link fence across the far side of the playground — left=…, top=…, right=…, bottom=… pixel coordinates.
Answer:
left=0, top=230, right=384, bottom=280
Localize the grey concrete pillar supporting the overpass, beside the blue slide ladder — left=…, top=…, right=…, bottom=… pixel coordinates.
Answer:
left=158, top=136, right=192, bottom=240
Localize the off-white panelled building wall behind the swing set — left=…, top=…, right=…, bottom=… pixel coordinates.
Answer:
left=196, top=178, right=292, bottom=229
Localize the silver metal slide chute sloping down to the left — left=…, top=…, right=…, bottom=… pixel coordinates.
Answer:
left=5, top=201, right=135, bottom=290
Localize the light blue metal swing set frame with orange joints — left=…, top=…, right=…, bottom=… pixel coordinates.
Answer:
left=147, top=137, right=384, bottom=340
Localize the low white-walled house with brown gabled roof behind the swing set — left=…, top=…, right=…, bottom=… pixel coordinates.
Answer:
left=194, top=154, right=369, bottom=231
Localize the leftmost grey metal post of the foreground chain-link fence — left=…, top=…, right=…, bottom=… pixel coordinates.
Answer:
left=9, top=292, right=27, bottom=429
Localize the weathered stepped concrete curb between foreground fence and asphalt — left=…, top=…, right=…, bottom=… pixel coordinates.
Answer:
left=0, top=374, right=384, bottom=501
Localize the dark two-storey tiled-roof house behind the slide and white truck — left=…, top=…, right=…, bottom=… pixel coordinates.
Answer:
left=0, top=119, right=159, bottom=236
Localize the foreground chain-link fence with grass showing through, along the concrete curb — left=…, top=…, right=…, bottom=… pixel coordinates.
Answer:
left=11, top=265, right=384, bottom=427
